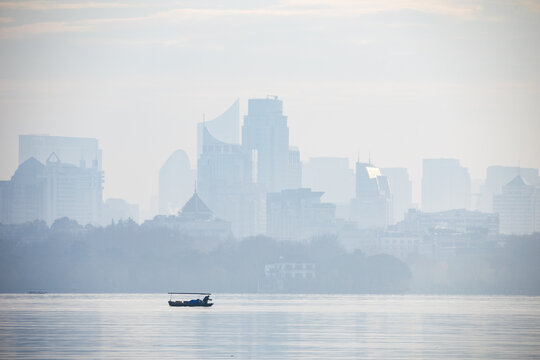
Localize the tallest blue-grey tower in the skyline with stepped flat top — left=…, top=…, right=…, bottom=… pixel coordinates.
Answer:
left=242, top=96, right=289, bottom=192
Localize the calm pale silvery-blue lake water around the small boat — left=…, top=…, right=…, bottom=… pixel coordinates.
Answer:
left=0, top=294, right=540, bottom=359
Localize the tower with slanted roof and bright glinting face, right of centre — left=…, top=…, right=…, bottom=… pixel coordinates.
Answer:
left=350, top=162, right=392, bottom=229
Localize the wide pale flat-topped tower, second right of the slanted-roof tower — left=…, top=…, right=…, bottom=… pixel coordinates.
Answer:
left=422, top=159, right=471, bottom=212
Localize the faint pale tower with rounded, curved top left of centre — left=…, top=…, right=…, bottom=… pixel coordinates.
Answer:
left=158, top=150, right=195, bottom=215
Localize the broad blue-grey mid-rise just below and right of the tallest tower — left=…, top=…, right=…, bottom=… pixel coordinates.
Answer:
left=266, top=188, right=336, bottom=240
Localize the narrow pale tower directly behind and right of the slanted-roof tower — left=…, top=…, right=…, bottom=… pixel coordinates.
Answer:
left=381, top=167, right=412, bottom=223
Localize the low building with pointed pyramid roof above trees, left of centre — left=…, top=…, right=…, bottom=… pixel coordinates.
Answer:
left=143, top=192, right=232, bottom=242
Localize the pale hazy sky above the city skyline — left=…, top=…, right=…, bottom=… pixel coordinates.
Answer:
left=0, top=0, right=540, bottom=209
